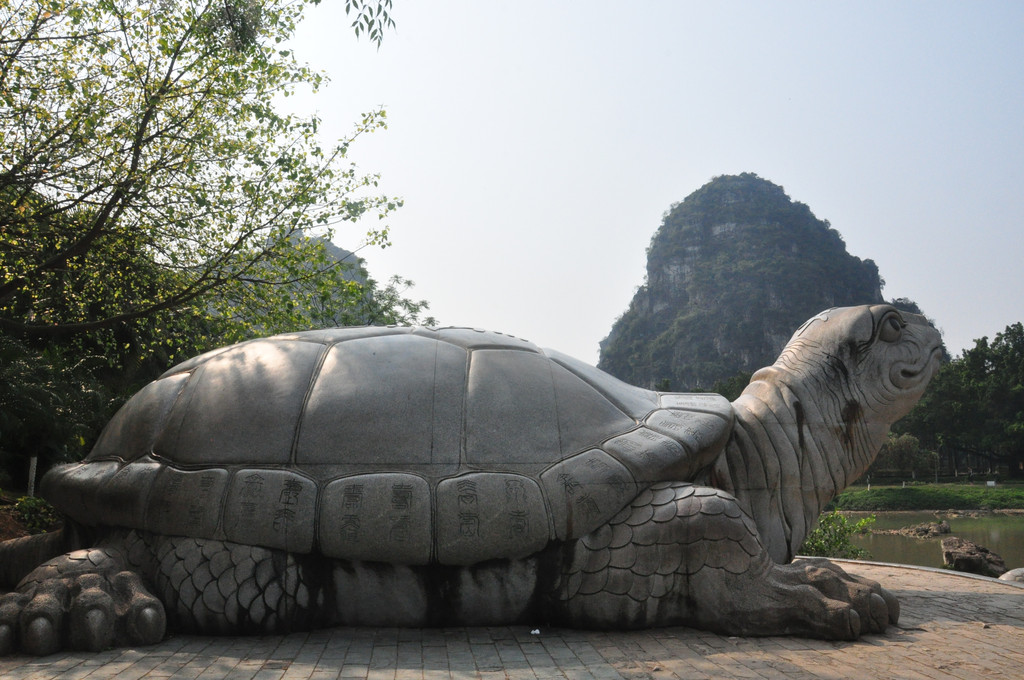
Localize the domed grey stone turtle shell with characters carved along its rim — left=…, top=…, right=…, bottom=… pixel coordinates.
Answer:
left=43, top=327, right=732, bottom=564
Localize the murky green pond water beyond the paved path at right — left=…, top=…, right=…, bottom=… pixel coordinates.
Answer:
left=844, top=512, right=1024, bottom=569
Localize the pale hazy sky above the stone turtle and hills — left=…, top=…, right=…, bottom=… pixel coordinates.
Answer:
left=292, top=0, right=1024, bottom=363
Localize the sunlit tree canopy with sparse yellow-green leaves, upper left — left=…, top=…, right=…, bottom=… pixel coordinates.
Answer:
left=0, top=0, right=400, bottom=350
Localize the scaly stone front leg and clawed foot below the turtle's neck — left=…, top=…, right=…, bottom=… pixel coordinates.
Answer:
left=550, top=482, right=899, bottom=640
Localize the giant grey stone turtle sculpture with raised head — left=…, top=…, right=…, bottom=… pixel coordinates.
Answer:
left=0, top=305, right=941, bottom=654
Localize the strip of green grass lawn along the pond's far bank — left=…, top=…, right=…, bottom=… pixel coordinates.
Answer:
left=833, top=482, right=1024, bottom=511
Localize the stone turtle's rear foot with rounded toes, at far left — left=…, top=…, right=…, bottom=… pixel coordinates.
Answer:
left=0, top=548, right=167, bottom=655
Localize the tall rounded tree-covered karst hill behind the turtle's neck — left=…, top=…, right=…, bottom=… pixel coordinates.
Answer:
left=599, top=173, right=914, bottom=390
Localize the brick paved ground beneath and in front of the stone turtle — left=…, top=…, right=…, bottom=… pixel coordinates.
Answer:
left=0, top=563, right=1024, bottom=680
